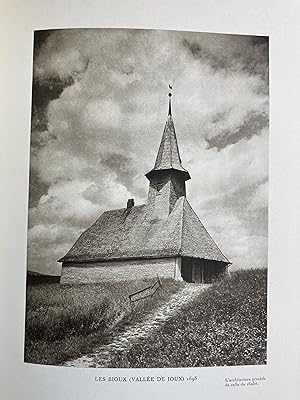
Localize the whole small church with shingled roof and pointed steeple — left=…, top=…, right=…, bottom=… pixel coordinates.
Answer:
left=58, top=93, right=230, bottom=285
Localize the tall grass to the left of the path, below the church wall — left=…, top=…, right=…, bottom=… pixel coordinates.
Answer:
left=25, top=280, right=182, bottom=365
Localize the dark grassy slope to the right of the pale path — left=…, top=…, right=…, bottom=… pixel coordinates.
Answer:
left=111, top=269, right=267, bottom=368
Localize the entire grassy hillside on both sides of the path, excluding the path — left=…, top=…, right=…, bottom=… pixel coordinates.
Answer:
left=25, top=269, right=267, bottom=368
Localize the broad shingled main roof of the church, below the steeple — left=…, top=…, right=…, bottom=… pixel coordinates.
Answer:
left=59, top=196, right=229, bottom=264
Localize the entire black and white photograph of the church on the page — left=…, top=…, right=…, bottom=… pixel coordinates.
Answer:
left=24, top=28, right=269, bottom=368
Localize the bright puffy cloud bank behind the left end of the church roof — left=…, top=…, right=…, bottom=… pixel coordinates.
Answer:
left=28, top=177, right=131, bottom=273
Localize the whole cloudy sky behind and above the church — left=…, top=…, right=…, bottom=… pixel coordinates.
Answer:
left=28, top=29, right=269, bottom=274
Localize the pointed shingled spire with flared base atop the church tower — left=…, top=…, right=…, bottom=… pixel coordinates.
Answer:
left=146, top=93, right=191, bottom=181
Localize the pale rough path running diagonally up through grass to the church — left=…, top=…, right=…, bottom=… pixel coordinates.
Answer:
left=62, top=285, right=209, bottom=368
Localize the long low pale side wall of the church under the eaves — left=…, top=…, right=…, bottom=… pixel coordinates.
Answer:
left=60, top=257, right=181, bottom=284
